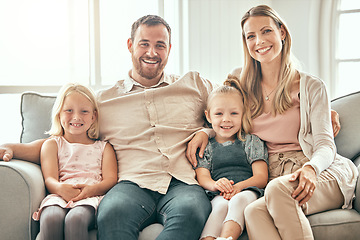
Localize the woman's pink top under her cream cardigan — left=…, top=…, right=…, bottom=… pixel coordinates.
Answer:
left=251, top=90, right=301, bottom=155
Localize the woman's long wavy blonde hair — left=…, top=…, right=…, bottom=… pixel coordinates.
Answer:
left=240, top=5, right=298, bottom=123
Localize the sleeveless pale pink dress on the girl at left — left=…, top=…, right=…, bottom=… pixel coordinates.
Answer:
left=33, top=137, right=106, bottom=220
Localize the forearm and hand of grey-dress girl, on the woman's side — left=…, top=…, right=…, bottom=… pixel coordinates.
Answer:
left=224, top=160, right=268, bottom=199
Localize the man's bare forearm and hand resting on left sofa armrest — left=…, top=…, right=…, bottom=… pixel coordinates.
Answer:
left=0, top=139, right=46, bottom=164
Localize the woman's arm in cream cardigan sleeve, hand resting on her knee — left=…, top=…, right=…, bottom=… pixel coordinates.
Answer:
left=290, top=76, right=340, bottom=205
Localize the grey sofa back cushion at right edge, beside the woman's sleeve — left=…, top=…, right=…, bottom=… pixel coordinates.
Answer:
left=331, top=91, right=360, bottom=164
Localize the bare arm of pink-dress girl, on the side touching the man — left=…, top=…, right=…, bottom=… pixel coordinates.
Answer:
left=71, top=143, right=118, bottom=202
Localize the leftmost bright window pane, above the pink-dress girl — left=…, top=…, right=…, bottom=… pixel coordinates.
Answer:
left=0, top=0, right=89, bottom=93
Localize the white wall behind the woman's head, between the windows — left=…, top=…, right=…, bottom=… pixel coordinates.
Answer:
left=184, top=0, right=321, bottom=83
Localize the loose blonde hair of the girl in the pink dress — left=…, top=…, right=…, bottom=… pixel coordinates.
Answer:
left=46, top=83, right=99, bottom=140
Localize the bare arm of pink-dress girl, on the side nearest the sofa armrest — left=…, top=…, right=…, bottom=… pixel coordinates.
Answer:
left=40, top=139, right=80, bottom=201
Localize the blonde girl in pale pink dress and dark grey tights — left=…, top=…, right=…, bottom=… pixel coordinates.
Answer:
left=33, top=84, right=117, bottom=239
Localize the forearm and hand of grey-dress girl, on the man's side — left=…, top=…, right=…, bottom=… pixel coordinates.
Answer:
left=195, top=167, right=234, bottom=193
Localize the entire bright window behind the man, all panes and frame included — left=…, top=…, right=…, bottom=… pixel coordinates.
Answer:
left=0, top=0, right=180, bottom=143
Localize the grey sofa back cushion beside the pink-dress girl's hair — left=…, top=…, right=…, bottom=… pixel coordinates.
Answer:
left=20, top=92, right=56, bottom=143
